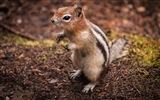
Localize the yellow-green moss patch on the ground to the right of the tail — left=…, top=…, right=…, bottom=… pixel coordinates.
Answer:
left=108, top=32, right=160, bottom=69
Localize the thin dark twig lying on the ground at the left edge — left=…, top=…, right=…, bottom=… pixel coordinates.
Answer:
left=0, top=23, right=39, bottom=41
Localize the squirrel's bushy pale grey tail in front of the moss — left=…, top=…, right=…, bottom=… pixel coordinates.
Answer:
left=109, top=37, right=128, bottom=63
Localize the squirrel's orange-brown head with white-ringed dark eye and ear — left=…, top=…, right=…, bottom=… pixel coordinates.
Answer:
left=51, top=4, right=85, bottom=30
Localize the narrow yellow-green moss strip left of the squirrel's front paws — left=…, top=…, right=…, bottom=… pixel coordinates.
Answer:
left=0, top=33, right=55, bottom=47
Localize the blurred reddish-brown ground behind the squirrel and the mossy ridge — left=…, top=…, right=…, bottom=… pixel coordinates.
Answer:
left=0, top=0, right=160, bottom=40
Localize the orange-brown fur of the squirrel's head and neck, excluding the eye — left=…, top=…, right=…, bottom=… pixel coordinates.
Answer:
left=51, top=4, right=87, bottom=34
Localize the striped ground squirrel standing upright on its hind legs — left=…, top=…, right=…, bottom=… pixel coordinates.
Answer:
left=51, top=4, right=126, bottom=93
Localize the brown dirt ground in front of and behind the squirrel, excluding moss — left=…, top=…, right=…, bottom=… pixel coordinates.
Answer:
left=0, top=0, right=160, bottom=100
